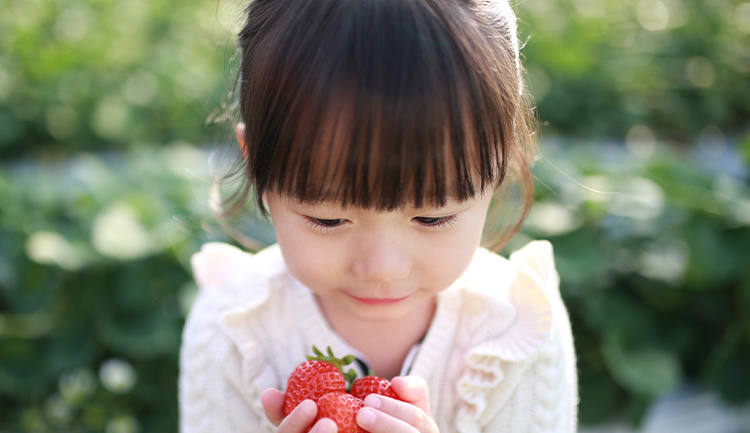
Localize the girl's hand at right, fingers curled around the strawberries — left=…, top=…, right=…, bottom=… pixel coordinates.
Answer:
left=357, top=376, right=438, bottom=433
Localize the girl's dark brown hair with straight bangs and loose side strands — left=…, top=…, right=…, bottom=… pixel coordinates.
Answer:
left=222, top=0, right=533, bottom=250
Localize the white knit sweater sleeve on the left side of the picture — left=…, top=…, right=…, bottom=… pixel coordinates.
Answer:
left=179, top=245, right=275, bottom=433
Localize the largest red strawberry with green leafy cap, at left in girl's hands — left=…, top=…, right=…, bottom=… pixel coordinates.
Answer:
left=284, top=346, right=356, bottom=416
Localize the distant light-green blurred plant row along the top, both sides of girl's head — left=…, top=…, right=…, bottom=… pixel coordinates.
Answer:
left=0, top=0, right=750, bottom=158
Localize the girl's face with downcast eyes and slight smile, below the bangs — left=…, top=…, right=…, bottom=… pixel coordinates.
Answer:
left=266, top=191, right=492, bottom=321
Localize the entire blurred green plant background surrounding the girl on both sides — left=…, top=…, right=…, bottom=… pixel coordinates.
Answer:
left=0, top=0, right=750, bottom=433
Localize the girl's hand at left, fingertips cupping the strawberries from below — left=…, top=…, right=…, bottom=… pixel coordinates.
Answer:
left=260, top=388, right=337, bottom=433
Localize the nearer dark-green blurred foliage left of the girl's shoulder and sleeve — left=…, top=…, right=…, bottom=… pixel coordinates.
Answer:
left=0, top=142, right=270, bottom=433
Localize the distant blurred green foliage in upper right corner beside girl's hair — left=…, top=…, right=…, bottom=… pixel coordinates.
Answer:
left=517, top=0, right=750, bottom=143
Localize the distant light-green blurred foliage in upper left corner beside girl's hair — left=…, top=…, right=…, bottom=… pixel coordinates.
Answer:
left=0, top=0, right=242, bottom=158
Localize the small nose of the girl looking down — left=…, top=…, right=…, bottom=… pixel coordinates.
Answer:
left=352, top=235, right=412, bottom=283
